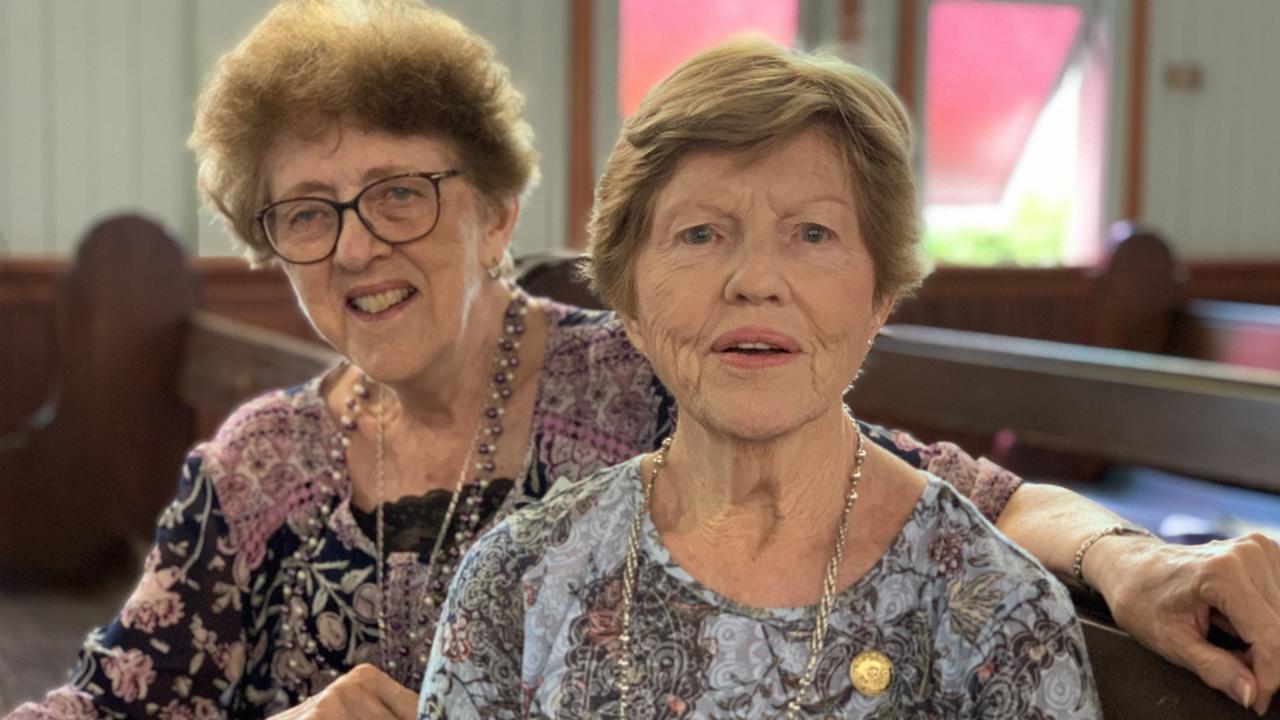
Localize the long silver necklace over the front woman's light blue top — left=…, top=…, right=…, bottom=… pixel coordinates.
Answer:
left=616, top=421, right=867, bottom=720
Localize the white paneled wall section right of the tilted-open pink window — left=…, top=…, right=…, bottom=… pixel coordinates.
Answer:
left=1143, top=0, right=1280, bottom=259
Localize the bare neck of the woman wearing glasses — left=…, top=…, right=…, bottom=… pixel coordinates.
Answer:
left=373, top=282, right=511, bottom=432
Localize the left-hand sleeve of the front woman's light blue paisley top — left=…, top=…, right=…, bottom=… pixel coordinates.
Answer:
left=417, top=524, right=534, bottom=720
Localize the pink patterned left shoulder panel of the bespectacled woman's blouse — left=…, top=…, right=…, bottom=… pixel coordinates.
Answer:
left=188, top=378, right=346, bottom=566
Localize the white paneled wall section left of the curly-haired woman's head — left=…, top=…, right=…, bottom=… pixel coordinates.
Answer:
left=0, top=0, right=193, bottom=254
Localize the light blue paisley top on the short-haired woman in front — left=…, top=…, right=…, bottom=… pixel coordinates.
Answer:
left=419, top=459, right=1101, bottom=720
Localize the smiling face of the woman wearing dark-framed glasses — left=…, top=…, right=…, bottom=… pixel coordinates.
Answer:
left=266, top=126, right=516, bottom=382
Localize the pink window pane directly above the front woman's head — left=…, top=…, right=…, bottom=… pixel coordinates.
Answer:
left=618, top=0, right=800, bottom=118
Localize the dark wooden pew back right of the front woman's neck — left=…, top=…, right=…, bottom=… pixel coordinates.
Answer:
left=852, top=325, right=1280, bottom=492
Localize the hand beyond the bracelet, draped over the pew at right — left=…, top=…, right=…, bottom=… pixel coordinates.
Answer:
left=1084, top=534, right=1280, bottom=715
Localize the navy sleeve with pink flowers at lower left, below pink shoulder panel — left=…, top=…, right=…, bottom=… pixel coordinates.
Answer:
left=10, top=451, right=246, bottom=720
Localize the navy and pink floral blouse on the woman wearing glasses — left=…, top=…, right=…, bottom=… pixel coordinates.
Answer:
left=13, top=302, right=1020, bottom=719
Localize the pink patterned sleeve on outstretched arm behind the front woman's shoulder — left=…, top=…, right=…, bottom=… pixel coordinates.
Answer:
left=859, top=421, right=1023, bottom=523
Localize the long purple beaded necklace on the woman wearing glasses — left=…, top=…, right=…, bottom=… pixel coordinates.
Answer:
left=340, top=286, right=529, bottom=679
